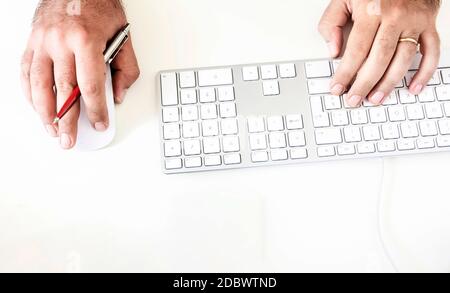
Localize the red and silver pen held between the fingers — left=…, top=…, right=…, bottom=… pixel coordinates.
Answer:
left=53, top=23, right=130, bottom=124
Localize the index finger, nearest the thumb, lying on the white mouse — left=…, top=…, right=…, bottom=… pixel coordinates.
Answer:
left=75, top=47, right=109, bottom=131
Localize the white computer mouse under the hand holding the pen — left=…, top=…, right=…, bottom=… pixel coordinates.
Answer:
left=75, top=66, right=116, bottom=151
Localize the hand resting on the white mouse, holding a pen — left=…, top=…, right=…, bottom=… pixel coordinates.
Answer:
left=22, top=0, right=139, bottom=149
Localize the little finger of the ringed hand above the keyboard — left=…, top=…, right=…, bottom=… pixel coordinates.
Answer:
left=409, top=31, right=441, bottom=95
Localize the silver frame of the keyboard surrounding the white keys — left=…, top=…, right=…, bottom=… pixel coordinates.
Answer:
left=156, top=52, right=450, bottom=174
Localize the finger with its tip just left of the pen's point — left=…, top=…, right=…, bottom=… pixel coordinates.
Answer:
left=30, top=53, right=57, bottom=137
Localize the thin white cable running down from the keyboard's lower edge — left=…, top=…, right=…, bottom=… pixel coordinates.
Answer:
left=376, top=158, right=400, bottom=273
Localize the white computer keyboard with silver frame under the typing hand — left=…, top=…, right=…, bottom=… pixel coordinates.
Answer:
left=158, top=52, right=450, bottom=174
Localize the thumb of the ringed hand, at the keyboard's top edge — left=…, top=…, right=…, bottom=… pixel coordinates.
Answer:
left=319, top=0, right=350, bottom=58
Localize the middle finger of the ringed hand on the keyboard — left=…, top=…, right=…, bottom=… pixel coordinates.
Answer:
left=348, top=24, right=402, bottom=106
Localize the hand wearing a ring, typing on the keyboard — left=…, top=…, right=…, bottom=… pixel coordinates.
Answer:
left=319, top=0, right=440, bottom=106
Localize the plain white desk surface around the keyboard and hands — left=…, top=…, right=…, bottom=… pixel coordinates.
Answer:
left=0, top=0, right=450, bottom=272
